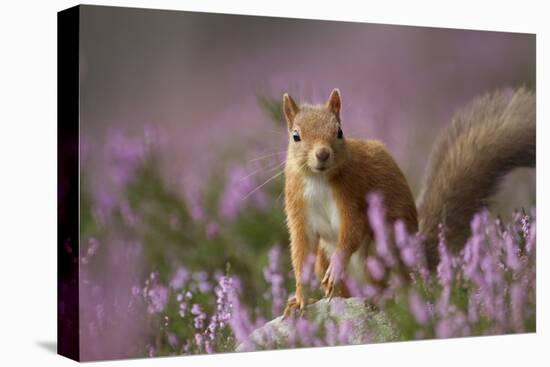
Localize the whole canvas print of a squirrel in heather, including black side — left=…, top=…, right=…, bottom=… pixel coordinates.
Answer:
left=58, top=6, right=536, bottom=361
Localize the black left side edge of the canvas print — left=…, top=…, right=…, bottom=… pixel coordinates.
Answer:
left=57, top=6, right=80, bottom=361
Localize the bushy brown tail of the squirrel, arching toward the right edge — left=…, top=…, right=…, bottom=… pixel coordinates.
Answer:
left=418, top=88, right=536, bottom=268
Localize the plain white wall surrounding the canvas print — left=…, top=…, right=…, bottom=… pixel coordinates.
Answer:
left=0, top=0, right=550, bottom=367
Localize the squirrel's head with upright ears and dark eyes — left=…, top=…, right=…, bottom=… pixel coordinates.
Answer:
left=283, top=89, right=345, bottom=174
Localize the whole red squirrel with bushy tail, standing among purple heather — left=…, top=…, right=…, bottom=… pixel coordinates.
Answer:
left=283, top=88, right=536, bottom=315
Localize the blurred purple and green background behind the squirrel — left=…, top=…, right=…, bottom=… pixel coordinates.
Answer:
left=75, top=6, right=535, bottom=359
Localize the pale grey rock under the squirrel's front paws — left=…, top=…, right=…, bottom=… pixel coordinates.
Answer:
left=236, top=297, right=398, bottom=352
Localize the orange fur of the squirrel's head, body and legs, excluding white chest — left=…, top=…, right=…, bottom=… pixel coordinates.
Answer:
left=283, top=90, right=418, bottom=312
